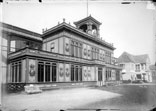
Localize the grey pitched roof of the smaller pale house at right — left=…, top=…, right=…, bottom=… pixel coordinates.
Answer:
left=117, top=52, right=149, bottom=63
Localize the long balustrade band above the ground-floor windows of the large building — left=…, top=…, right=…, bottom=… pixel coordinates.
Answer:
left=8, top=47, right=117, bottom=66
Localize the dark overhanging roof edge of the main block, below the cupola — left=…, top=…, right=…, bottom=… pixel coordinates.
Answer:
left=42, top=22, right=115, bottom=50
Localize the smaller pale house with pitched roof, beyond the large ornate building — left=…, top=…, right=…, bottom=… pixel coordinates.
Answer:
left=117, top=52, right=152, bottom=82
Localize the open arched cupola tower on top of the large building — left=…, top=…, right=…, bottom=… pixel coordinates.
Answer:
left=74, top=15, right=101, bottom=37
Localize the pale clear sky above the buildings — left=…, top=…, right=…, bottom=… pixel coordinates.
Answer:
left=0, top=0, right=156, bottom=64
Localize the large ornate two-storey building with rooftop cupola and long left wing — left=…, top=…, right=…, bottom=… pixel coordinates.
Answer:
left=1, top=16, right=121, bottom=90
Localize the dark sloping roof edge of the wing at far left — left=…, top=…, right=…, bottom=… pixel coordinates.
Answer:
left=0, top=22, right=42, bottom=41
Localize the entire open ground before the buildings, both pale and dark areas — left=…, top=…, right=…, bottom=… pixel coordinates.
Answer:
left=2, top=84, right=156, bottom=111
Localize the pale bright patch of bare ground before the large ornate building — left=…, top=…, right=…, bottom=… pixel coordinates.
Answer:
left=2, top=88, right=122, bottom=111
